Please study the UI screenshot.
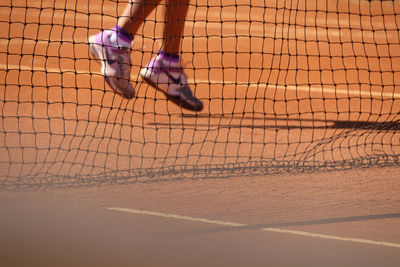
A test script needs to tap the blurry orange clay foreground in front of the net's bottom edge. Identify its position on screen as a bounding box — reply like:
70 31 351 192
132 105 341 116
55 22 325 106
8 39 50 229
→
0 168 400 266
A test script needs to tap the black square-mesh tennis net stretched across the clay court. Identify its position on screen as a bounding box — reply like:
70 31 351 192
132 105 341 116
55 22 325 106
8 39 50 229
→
0 0 400 186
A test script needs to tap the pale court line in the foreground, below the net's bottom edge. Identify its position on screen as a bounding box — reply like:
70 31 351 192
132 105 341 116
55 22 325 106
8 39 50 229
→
103 207 400 248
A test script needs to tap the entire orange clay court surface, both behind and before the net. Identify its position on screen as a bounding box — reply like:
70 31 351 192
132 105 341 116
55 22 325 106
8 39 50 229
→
0 1 400 266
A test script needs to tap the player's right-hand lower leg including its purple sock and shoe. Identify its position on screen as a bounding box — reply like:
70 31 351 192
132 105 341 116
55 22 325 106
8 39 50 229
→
140 0 203 111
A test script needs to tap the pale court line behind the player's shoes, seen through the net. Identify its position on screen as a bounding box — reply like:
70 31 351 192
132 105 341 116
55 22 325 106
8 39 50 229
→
0 64 400 100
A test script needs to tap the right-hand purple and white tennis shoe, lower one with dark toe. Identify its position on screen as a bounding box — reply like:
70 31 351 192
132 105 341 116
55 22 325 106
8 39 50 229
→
140 55 203 111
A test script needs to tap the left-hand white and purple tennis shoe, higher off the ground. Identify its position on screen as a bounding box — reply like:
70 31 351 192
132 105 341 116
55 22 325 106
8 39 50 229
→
89 30 135 98
